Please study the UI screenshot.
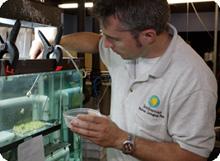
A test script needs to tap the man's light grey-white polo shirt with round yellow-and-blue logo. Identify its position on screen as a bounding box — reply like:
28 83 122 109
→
99 25 217 161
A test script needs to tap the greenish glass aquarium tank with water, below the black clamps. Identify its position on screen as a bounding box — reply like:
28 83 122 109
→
0 70 82 161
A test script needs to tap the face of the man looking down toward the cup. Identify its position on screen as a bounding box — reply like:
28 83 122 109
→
102 16 144 59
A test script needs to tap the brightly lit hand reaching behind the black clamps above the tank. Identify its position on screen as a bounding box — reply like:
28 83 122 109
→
29 40 43 59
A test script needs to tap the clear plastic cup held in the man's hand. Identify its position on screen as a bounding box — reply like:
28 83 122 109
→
63 108 101 128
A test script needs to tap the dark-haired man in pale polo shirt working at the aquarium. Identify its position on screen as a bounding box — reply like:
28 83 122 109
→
31 0 217 161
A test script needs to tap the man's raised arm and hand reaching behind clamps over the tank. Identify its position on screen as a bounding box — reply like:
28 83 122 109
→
29 32 101 59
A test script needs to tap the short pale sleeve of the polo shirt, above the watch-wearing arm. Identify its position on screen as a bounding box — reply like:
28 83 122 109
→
168 89 217 157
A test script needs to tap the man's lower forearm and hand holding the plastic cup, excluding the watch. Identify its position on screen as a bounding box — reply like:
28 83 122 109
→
71 115 207 161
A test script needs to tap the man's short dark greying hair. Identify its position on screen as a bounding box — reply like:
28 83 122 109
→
93 0 170 34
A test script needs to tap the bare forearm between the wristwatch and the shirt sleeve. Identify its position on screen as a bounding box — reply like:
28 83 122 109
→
128 137 207 161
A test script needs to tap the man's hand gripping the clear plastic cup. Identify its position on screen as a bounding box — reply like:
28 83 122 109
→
71 114 127 149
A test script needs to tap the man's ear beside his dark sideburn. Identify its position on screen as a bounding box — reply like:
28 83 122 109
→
140 29 157 44
